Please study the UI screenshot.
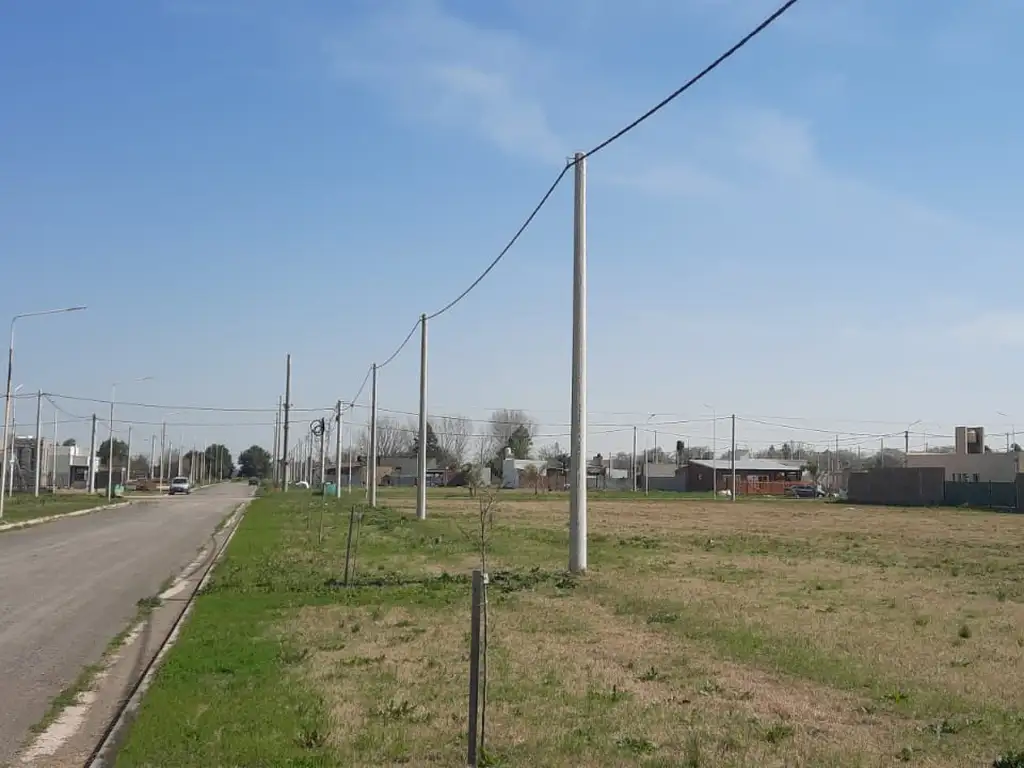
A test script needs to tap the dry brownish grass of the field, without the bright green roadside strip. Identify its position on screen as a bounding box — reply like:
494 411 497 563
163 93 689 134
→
288 495 1024 766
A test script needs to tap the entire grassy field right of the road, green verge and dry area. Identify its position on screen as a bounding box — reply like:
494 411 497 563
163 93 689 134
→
117 490 1024 767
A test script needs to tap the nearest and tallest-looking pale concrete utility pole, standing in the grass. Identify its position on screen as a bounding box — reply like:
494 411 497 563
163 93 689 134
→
569 152 587 573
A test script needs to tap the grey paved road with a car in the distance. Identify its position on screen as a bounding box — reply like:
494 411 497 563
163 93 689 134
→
0 482 251 765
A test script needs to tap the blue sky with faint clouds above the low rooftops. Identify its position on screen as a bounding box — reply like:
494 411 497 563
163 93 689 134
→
6 0 1024 451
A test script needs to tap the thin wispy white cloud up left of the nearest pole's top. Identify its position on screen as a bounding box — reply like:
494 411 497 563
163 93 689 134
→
328 0 564 161
